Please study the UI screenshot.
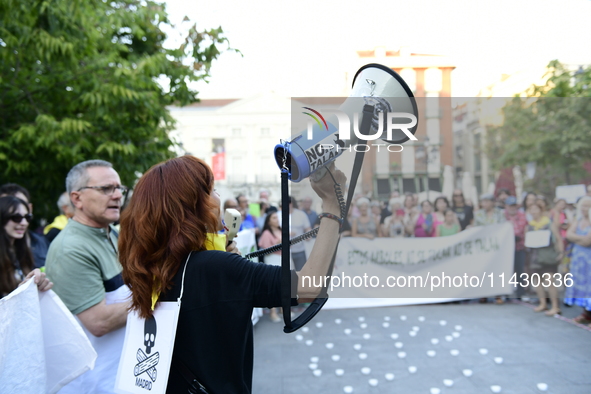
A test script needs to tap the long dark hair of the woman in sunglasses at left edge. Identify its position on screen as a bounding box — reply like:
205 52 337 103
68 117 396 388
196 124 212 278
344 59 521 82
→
0 196 35 294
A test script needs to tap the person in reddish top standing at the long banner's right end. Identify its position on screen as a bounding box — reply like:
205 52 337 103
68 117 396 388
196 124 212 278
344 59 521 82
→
505 196 528 298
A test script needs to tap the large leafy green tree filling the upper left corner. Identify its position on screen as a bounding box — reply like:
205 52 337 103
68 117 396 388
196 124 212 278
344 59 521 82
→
0 0 236 222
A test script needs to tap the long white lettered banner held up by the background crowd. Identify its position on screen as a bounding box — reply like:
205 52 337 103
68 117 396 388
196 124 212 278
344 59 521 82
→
304 223 515 308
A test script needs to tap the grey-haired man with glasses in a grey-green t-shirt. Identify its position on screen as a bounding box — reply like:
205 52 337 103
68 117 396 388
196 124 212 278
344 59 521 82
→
47 160 130 394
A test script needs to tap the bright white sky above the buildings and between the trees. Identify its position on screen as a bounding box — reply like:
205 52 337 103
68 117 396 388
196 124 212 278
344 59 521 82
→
160 0 591 99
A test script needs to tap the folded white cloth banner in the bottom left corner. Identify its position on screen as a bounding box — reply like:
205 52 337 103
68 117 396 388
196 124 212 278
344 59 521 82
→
0 280 97 394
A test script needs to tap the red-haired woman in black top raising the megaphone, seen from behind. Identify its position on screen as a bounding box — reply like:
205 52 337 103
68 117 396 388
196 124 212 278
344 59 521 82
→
119 156 346 394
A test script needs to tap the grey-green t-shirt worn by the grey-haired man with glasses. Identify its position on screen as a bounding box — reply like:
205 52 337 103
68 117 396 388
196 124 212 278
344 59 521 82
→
45 219 123 315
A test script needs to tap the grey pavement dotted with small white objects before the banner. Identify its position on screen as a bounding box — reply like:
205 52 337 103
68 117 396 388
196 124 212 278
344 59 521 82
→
253 301 591 394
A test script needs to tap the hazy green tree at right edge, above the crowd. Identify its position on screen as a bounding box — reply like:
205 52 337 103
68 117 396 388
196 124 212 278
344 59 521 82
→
488 61 591 192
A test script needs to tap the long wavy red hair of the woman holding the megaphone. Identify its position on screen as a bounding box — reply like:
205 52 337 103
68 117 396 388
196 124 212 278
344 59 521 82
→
119 156 219 318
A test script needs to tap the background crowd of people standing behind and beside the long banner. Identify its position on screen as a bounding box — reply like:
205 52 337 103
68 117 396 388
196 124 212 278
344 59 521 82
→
240 185 591 324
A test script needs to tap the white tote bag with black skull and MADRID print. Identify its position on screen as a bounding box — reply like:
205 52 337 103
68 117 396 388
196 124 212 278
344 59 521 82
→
115 254 191 394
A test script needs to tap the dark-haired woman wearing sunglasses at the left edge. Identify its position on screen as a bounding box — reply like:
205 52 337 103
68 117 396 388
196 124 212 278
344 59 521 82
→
0 196 53 297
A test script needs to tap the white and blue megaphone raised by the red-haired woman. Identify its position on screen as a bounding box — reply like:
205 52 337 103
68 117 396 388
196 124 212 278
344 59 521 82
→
275 64 418 182
